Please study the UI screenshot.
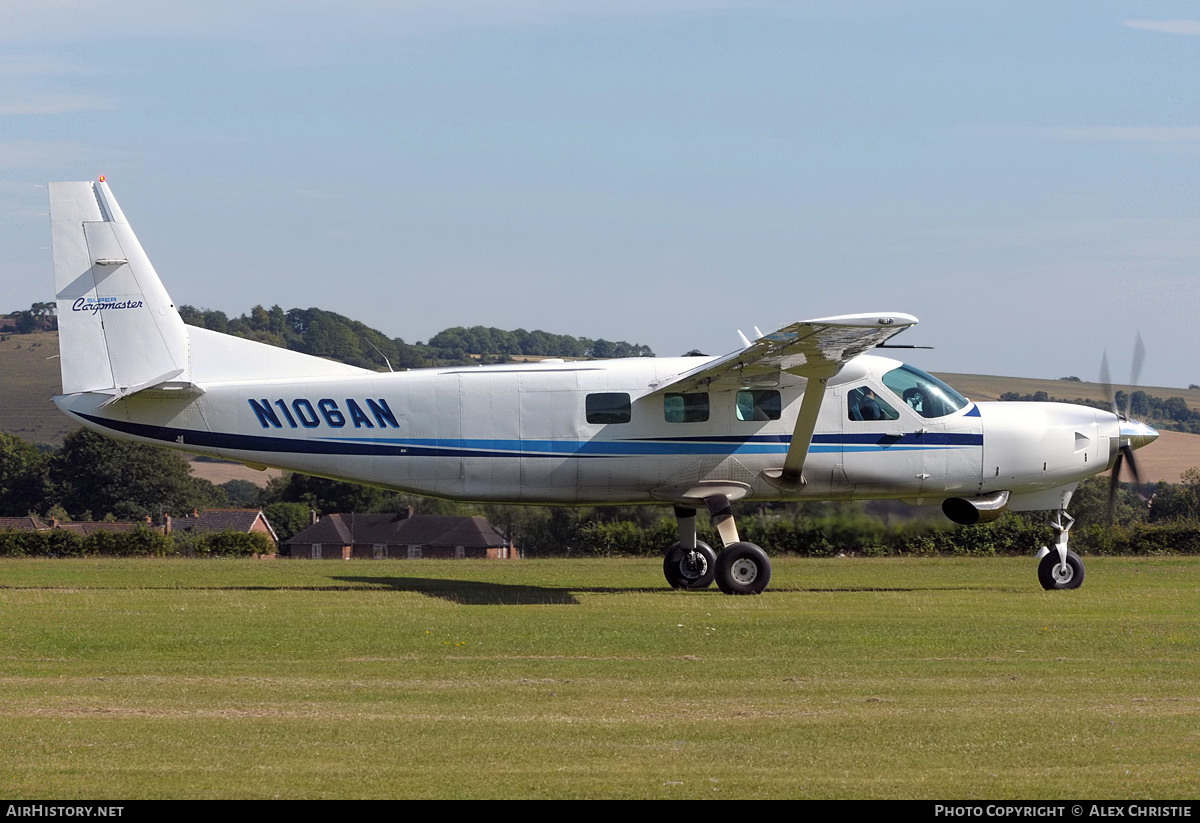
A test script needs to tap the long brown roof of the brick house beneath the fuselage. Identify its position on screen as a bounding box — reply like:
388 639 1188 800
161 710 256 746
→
290 513 508 548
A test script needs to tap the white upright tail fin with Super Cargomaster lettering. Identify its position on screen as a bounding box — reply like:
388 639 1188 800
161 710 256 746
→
50 181 188 400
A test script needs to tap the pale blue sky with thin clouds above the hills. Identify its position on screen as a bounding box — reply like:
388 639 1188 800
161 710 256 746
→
0 0 1200 386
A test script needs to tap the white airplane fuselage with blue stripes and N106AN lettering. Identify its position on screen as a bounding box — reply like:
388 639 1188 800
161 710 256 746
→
58 355 1120 509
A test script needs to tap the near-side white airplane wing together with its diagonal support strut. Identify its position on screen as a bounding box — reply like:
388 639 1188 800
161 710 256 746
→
650 313 917 491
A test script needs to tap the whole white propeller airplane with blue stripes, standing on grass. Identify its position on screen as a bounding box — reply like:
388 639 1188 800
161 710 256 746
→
49 178 1158 594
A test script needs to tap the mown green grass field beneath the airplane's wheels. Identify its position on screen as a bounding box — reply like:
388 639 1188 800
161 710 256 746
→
0 558 1200 799
